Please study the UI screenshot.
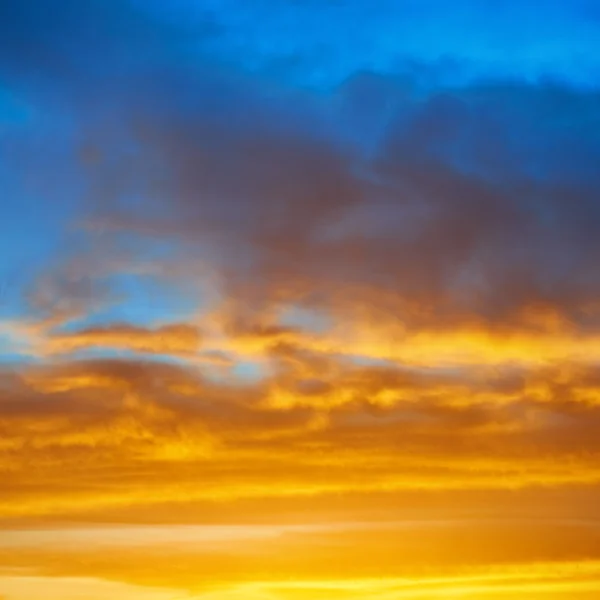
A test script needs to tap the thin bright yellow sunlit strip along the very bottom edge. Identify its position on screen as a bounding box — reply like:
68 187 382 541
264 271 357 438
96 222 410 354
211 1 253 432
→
0 562 600 600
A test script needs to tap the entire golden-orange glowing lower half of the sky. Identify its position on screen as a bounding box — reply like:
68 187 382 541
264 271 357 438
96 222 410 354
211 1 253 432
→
0 282 600 600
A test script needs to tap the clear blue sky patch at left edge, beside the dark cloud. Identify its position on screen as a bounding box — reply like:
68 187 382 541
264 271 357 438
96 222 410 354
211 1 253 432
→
0 79 85 317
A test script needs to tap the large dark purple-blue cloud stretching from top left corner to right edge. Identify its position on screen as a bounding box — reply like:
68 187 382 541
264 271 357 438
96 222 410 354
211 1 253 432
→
2 2 600 332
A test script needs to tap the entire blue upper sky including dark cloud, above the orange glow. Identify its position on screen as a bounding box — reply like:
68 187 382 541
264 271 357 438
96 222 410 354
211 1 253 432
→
0 0 600 360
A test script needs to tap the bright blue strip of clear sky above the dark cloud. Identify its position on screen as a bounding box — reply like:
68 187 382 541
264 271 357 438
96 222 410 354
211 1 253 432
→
137 0 600 89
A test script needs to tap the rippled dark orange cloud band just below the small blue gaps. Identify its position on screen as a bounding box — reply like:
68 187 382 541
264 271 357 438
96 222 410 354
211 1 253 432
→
0 357 600 517
